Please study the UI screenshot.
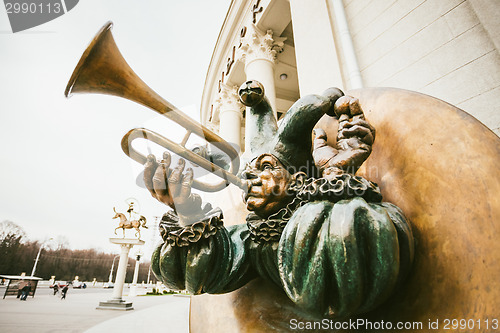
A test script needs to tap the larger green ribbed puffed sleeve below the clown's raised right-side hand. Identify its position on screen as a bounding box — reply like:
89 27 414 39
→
277 198 413 318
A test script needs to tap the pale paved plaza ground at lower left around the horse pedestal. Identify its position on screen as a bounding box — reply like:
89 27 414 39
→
0 287 189 333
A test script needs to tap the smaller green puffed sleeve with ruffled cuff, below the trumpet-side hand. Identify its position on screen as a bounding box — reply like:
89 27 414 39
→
151 210 255 295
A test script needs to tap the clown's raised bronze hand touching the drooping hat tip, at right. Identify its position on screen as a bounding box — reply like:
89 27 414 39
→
313 96 375 178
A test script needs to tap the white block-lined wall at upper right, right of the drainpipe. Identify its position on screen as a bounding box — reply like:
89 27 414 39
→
344 0 500 134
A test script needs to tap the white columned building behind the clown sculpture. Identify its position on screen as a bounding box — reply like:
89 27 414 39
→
201 0 500 223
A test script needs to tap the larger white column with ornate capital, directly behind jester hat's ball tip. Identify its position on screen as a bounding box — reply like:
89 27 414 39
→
237 24 286 117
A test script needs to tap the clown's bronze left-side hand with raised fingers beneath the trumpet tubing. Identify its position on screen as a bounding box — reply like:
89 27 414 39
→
144 152 211 225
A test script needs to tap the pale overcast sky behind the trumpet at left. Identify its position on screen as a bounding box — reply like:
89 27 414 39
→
0 0 230 254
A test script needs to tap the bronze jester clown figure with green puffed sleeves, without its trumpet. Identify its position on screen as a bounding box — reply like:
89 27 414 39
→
144 81 413 318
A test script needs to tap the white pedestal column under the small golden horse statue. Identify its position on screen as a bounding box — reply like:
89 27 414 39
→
97 238 145 311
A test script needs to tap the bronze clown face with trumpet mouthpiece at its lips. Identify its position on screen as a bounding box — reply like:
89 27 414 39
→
242 154 293 217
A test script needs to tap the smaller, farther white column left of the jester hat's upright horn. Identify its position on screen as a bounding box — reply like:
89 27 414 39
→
214 84 245 149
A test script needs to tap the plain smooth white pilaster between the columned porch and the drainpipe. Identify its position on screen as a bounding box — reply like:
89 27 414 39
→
290 0 344 96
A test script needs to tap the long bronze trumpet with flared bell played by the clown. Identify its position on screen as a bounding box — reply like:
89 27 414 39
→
64 22 245 192
